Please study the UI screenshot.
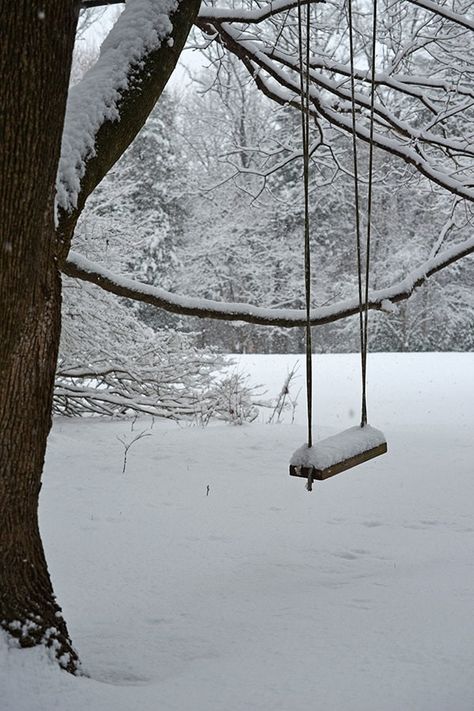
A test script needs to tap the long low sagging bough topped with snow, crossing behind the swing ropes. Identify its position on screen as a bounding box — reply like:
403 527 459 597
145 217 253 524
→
63 238 474 328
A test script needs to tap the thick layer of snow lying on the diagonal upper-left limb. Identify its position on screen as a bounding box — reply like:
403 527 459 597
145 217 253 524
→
57 0 178 211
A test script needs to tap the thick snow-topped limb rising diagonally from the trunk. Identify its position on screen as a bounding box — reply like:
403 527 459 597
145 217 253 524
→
58 0 199 258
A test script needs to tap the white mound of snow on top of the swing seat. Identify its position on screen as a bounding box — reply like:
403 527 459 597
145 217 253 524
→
290 425 386 469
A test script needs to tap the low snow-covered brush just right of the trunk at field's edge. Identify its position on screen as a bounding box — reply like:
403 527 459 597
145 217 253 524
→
53 352 262 424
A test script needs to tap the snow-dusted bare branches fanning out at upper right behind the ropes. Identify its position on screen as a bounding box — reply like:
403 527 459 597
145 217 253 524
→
197 2 474 201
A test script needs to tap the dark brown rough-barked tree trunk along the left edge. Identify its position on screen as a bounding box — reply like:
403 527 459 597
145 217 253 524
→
0 0 78 671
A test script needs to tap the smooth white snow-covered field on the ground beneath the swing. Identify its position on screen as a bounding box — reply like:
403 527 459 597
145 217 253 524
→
0 354 474 711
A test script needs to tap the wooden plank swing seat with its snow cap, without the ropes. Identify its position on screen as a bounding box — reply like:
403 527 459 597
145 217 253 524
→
290 425 387 481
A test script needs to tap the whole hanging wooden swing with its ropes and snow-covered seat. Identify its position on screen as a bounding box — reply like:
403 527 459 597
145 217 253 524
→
290 0 387 491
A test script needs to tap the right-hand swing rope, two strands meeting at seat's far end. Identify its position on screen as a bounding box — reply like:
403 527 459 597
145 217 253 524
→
348 0 377 427
